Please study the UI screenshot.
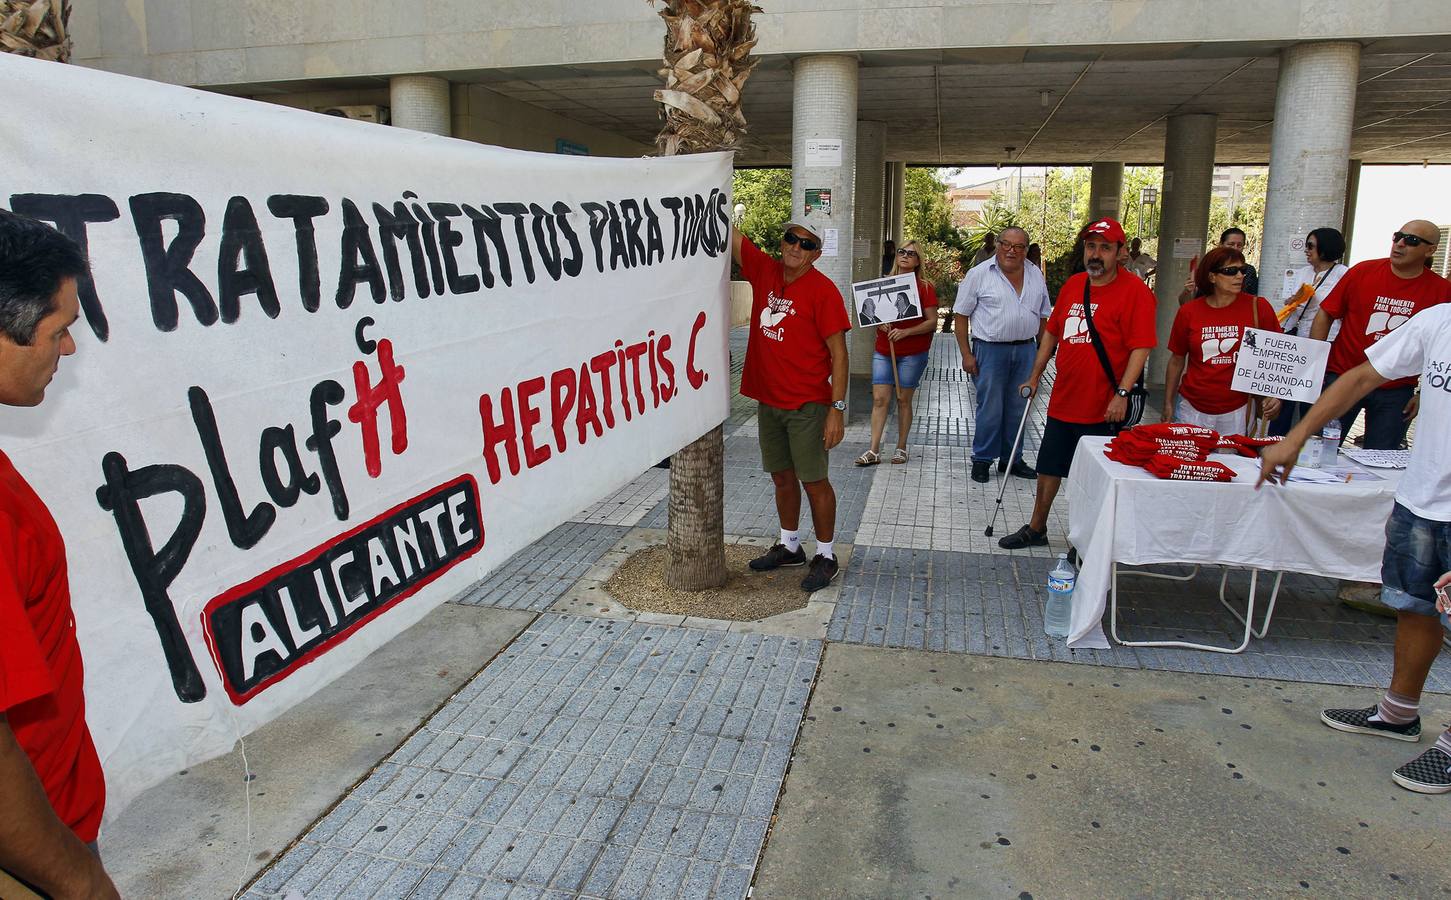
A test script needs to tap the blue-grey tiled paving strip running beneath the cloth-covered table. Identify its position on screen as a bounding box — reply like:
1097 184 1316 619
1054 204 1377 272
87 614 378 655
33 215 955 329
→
827 544 1451 691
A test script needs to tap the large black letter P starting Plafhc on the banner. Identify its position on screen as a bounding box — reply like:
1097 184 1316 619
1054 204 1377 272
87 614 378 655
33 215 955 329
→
96 453 206 703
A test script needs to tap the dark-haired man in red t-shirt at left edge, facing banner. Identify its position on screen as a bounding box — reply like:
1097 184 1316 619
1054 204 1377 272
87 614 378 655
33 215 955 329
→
0 210 116 897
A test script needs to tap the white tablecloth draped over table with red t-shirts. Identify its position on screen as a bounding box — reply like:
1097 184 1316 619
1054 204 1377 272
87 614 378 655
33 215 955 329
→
1068 437 1402 647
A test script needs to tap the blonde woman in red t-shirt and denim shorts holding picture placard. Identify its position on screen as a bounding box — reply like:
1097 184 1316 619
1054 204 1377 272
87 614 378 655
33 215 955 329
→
856 241 937 466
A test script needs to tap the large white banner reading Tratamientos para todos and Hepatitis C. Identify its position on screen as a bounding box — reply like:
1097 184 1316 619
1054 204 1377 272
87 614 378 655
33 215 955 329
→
0 55 731 816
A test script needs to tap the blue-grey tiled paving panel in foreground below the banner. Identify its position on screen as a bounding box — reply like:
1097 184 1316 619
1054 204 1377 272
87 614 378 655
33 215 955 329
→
247 615 821 900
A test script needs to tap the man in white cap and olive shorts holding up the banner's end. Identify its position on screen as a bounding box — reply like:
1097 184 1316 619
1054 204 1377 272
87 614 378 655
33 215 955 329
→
731 221 852 592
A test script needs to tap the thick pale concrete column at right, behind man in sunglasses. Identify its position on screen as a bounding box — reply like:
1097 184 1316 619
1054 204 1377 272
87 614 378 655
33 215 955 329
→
1259 41 1360 306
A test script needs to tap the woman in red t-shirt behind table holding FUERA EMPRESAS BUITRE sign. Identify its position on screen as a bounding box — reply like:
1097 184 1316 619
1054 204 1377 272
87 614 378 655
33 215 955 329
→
1164 247 1280 434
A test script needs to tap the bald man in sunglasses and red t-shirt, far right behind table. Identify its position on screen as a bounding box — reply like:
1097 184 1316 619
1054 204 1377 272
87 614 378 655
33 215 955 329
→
1310 219 1451 450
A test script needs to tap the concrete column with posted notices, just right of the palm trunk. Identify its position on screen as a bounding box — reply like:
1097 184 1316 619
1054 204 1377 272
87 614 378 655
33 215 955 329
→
791 55 858 400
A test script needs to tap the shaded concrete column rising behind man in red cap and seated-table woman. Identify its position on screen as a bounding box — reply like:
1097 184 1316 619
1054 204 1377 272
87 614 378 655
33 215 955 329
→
1146 113 1219 385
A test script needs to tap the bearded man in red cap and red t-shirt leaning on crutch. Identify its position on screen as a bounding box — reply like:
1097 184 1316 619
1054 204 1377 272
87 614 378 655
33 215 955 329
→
998 219 1158 550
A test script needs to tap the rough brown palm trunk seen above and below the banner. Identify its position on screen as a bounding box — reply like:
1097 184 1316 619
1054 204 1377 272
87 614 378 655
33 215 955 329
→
649 0 760 591
